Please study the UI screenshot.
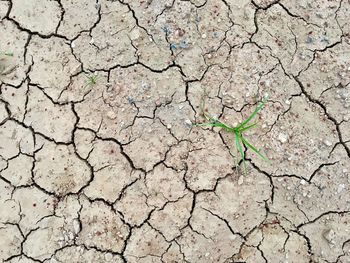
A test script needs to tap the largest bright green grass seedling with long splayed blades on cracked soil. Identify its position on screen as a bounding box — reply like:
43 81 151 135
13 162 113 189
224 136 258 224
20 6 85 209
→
194 96 268 171
